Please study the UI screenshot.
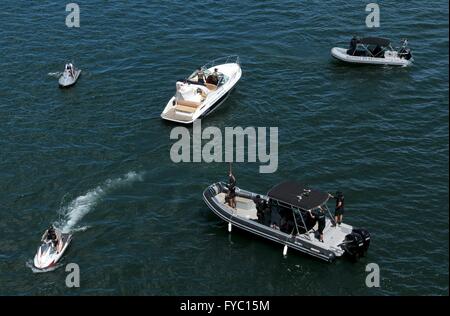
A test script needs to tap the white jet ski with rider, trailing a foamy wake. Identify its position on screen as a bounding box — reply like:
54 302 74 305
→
33 227 72 269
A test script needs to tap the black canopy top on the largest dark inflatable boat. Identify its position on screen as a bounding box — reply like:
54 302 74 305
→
267 181 329 211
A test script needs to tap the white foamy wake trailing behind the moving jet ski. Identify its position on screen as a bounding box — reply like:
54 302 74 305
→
55 171 144 233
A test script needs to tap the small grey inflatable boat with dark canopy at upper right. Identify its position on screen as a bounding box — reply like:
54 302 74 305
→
331 37 413 67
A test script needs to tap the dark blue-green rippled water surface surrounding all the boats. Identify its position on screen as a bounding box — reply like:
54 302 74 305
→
0 0 449 295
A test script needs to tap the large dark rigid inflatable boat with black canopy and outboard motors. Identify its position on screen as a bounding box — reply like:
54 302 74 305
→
203 181 370 262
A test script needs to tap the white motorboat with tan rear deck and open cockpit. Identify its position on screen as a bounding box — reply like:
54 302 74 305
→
161 56 242 124
